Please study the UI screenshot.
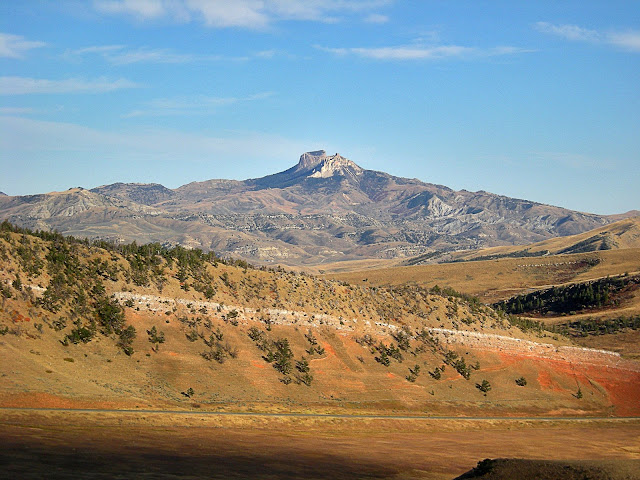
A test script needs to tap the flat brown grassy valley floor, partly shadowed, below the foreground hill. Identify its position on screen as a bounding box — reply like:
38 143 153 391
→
0 408 640 480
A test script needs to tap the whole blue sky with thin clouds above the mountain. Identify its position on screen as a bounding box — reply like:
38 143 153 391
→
0 0 640 214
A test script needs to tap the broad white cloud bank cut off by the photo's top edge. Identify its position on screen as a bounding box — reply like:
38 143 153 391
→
93 0 393 29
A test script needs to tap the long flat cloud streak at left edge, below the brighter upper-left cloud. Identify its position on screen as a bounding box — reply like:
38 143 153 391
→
0 77 140 95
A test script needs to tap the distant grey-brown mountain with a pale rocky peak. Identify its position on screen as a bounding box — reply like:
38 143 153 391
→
0 150 632 265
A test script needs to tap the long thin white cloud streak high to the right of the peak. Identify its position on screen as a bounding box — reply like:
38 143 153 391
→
316 45 532 61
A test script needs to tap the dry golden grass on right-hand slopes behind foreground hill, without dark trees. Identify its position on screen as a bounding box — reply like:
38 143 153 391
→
326 223 640 358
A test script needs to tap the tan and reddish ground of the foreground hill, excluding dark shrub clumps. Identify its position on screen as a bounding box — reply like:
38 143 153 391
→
0 229 640 416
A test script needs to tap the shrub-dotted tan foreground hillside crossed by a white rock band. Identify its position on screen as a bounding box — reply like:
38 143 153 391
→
0 223 640 414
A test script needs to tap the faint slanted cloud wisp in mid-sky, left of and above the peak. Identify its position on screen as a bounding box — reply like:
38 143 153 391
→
123 92 274 118
